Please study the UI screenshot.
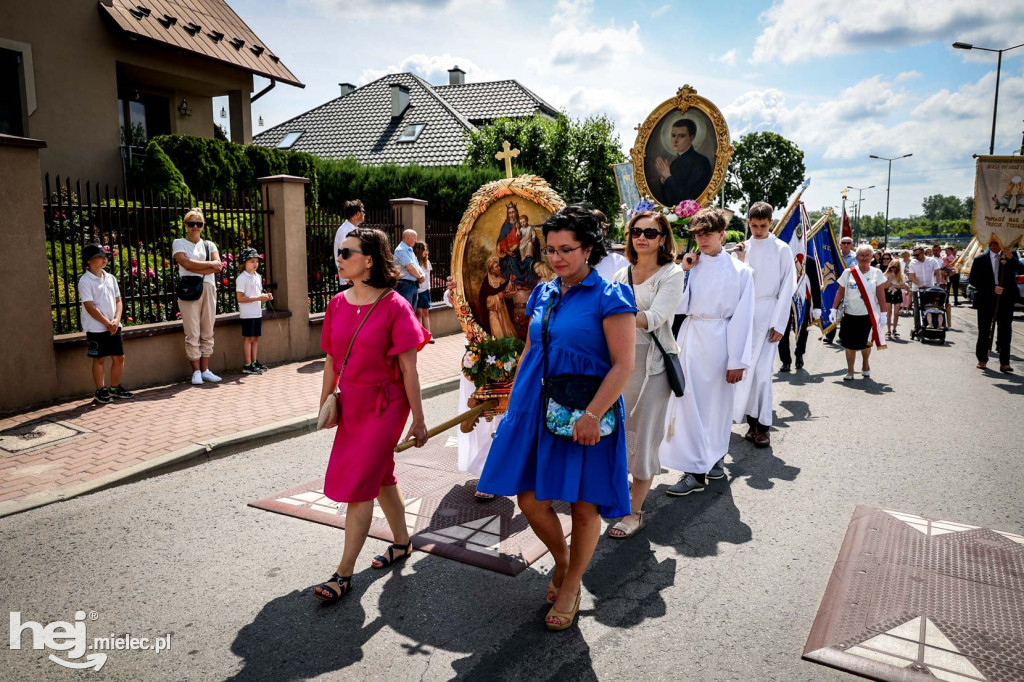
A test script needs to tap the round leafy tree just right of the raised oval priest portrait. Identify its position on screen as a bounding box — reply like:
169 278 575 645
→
725 132 807 213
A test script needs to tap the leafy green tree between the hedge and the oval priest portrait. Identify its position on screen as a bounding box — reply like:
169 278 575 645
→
466 115 626 217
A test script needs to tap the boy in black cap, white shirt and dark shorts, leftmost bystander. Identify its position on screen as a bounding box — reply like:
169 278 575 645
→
78 244 132 404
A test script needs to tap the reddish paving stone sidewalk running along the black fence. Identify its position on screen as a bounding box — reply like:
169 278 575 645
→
0 334 466 516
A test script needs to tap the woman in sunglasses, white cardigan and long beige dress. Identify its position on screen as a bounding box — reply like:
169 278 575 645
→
608 212 683 538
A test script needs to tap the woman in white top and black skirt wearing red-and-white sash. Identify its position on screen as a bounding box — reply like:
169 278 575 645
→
833 244 888 381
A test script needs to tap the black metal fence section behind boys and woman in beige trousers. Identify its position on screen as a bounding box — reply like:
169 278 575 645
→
43 174 273 334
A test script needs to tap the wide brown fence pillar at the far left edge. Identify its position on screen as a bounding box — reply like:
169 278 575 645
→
0 135 59 412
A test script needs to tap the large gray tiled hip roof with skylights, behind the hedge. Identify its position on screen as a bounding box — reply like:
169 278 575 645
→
253 73 473 166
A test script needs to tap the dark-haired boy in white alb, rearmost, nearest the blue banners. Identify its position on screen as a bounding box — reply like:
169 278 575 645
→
735 202 797 447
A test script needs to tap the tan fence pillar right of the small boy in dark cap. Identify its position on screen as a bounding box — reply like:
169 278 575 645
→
259 175 309 361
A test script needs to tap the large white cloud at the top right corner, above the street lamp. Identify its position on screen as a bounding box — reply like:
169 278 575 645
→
751 0 1024 63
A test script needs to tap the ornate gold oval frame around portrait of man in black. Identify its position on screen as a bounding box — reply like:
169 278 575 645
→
630 85 734 207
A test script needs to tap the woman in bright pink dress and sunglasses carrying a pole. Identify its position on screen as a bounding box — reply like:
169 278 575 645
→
313 227 430 601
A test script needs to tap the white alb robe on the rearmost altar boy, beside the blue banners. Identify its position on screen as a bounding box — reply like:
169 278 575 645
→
734 235 797 426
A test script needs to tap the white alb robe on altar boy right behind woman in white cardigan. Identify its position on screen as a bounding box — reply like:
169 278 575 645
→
658 250 754 473
